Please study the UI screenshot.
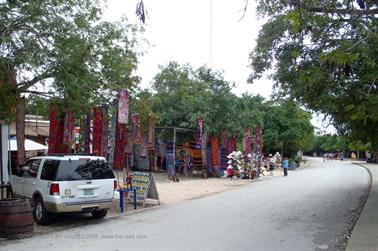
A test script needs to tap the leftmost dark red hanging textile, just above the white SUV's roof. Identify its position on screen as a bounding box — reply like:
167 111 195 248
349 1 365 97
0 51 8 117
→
48 106 64 154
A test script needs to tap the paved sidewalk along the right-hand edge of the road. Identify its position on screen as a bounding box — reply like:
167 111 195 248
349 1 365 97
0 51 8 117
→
345 162 378 251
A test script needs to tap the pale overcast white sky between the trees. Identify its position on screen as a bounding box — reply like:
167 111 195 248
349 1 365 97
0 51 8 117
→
104 0 334 132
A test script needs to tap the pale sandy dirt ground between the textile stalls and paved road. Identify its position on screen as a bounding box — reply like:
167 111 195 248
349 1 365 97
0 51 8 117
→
24 169 282 235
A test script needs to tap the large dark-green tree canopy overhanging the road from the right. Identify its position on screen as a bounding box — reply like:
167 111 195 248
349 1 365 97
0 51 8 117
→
249 0 378 148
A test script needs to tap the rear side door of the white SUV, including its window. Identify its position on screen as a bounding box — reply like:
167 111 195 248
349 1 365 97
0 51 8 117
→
22 159 41 198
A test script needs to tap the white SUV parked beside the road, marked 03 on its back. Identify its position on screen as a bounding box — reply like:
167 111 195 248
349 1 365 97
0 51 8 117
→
12 155 117 225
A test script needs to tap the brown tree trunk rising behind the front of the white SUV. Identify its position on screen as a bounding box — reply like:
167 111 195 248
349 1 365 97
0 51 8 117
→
16 98 26 164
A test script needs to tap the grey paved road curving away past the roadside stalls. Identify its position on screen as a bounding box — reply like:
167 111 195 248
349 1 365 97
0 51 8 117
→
0 160 369 251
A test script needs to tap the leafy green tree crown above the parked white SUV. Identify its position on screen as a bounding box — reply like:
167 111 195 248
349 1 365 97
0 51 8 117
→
0 0 139 159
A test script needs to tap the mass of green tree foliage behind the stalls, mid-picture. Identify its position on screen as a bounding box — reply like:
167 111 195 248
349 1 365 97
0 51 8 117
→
151 62 313 155
